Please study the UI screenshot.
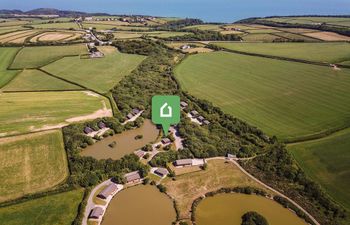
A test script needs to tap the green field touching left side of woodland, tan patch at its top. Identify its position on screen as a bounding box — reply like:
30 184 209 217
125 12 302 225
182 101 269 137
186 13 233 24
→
43 47 145 93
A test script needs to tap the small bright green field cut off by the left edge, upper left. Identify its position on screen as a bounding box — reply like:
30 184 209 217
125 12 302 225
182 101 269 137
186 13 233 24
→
0 48 19 88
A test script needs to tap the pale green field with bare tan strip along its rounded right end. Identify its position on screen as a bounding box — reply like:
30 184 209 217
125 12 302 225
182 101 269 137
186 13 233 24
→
0 91 111 137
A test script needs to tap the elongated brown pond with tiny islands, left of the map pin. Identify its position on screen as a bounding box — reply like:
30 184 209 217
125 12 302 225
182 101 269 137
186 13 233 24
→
81 120 159 159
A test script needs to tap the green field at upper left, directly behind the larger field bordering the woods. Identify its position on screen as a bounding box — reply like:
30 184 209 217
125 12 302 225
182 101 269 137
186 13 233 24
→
11 44 87 69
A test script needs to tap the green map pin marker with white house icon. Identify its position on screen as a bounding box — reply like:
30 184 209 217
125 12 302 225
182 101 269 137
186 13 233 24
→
152 95 180 135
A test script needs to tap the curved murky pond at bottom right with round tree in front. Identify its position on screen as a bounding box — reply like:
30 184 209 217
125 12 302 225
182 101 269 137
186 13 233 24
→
196 194 306 225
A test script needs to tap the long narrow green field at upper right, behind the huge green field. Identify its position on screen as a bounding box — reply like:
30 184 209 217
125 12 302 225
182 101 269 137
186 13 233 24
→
215 42 350 63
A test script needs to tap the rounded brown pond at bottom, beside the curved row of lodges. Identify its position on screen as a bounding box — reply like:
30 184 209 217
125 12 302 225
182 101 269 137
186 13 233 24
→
102 185 176 225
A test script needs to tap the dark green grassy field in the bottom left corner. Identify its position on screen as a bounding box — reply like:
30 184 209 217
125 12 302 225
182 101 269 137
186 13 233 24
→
0 189 84 225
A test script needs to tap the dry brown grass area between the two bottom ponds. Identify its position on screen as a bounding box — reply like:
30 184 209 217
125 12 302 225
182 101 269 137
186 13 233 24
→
162 160 269 219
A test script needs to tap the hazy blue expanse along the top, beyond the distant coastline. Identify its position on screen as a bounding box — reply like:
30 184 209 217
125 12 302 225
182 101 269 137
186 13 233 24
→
0 0 350 22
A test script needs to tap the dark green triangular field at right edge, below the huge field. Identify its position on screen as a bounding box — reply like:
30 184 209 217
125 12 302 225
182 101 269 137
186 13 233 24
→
288 129 350 210
